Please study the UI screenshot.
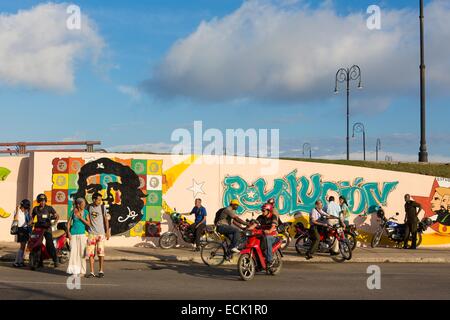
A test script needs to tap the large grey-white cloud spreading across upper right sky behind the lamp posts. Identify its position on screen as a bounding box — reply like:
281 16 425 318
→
144 0 450 105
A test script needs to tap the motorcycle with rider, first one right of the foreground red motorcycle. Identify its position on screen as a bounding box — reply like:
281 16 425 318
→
295 218 352 262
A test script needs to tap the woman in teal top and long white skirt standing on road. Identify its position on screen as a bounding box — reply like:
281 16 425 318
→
67 198 90 275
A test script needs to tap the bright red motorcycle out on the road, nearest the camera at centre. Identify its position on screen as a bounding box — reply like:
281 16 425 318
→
238 221 283 281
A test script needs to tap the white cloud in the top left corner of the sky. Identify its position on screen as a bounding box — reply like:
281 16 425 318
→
0 3 104 92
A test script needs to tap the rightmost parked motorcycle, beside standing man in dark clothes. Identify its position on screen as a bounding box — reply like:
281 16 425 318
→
371 210 433 248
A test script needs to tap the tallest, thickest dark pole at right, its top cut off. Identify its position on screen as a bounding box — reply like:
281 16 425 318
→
419 0 428 162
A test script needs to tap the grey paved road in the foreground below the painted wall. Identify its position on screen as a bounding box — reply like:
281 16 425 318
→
0 261 450 300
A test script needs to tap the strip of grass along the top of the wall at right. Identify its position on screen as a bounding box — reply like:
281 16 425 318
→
282 158 450 178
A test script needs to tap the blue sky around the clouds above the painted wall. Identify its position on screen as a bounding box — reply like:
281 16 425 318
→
0 0 450 161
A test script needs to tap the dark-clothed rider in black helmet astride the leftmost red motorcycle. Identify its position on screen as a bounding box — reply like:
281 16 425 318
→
31 193 59 268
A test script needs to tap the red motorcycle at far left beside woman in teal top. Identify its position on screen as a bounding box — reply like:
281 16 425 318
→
27 215 70 270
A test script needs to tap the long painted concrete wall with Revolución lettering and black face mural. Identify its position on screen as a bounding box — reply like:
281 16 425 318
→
0 152 450 246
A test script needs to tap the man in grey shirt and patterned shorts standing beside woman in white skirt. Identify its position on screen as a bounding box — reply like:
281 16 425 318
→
86 193 111 278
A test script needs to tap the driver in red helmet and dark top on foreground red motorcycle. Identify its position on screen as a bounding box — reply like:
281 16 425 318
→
248 203 278 268
